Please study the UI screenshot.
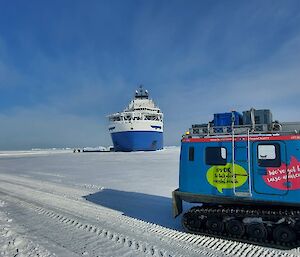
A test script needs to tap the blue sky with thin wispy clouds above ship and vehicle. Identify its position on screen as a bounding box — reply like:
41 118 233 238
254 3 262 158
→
0 0 300 150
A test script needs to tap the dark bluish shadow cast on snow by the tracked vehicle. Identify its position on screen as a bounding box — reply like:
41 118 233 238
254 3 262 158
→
84 189 189 230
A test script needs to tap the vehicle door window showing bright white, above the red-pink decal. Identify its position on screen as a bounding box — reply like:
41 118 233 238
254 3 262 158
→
257 143 281 167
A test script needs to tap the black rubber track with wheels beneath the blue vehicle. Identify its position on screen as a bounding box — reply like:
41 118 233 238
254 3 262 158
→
182 206 300 249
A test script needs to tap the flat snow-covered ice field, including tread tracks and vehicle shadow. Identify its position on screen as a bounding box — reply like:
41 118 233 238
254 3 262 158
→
0 147 300 257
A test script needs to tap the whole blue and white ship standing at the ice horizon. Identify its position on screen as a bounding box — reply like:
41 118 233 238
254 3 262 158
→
108 86 163 152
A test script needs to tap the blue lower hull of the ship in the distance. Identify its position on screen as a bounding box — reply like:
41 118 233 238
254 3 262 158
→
111 131 163 152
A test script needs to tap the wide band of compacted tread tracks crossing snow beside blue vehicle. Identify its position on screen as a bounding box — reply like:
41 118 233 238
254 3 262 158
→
0 175 299 257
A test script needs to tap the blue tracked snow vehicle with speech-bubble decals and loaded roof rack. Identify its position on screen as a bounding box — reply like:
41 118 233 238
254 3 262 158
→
173 109 300 248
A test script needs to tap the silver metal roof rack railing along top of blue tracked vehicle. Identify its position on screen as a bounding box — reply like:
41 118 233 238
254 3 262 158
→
187 122 300 137
